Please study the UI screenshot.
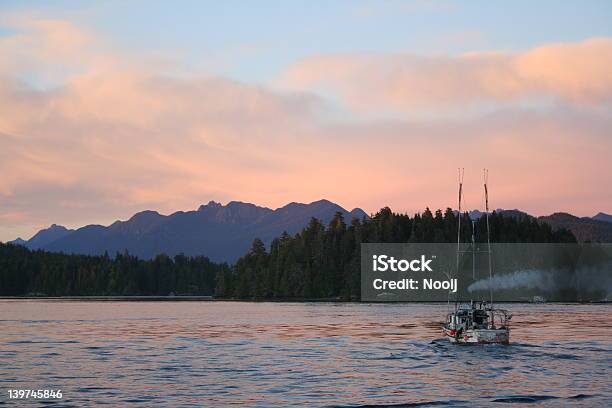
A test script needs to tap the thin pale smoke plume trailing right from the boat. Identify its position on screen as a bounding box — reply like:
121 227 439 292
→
468 269 559 292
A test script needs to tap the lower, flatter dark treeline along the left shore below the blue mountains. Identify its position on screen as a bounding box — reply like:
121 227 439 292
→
0 244 230 296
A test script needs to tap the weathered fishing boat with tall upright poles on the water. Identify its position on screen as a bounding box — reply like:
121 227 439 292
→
443 169 512 344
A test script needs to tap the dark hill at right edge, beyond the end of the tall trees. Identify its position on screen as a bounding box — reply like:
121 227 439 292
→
538 213 612 242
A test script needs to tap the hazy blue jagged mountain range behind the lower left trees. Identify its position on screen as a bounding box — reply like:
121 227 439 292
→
16 200 367 262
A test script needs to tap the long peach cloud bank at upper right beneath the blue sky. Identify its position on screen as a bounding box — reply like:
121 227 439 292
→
278 38 612 111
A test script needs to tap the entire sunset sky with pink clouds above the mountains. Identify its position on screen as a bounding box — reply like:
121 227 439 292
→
0 0 612 241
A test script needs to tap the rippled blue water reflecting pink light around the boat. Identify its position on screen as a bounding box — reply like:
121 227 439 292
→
0 301 612 407
